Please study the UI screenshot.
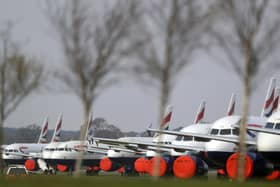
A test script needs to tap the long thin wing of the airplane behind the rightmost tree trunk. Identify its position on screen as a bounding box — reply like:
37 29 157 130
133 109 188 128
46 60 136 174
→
147 128 256 145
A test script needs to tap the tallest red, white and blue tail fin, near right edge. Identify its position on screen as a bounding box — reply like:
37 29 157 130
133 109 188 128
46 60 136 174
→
261 78 276 117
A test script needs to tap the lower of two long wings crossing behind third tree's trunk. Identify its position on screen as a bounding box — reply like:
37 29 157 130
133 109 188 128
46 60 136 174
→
91 138 204 154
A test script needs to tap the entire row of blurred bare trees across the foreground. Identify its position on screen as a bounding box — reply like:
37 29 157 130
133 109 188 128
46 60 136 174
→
0 0 280 181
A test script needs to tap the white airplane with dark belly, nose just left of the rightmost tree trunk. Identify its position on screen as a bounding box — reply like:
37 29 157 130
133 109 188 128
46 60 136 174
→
149 79 276 178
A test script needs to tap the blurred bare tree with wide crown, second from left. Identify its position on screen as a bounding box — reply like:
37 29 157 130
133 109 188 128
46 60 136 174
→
45 0 144 175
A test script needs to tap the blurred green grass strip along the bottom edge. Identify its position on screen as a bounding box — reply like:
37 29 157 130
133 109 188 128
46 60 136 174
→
0 176 280 187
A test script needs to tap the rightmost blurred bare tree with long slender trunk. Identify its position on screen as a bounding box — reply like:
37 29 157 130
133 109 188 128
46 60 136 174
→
208 0 280 181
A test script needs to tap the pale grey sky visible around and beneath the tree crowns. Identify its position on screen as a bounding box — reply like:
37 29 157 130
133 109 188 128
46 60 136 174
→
0 0 280 131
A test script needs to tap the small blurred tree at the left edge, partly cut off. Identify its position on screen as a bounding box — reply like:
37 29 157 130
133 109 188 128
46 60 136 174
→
0 22 43 169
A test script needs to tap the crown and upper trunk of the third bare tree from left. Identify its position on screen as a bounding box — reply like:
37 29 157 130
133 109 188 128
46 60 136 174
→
133 0 207 122
